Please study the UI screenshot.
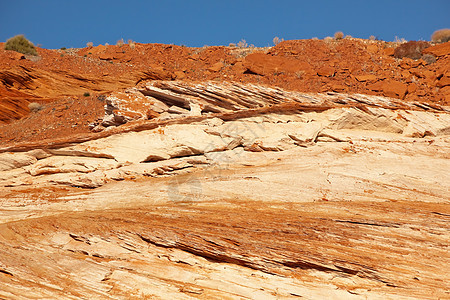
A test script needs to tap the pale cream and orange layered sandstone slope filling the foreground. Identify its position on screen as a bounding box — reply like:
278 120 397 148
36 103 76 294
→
0 81 450 299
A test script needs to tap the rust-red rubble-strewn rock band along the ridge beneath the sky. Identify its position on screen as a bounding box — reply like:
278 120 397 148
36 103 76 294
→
0 38 450 123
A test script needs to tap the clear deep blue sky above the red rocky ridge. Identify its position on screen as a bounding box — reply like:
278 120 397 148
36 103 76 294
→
0 0 450 49
